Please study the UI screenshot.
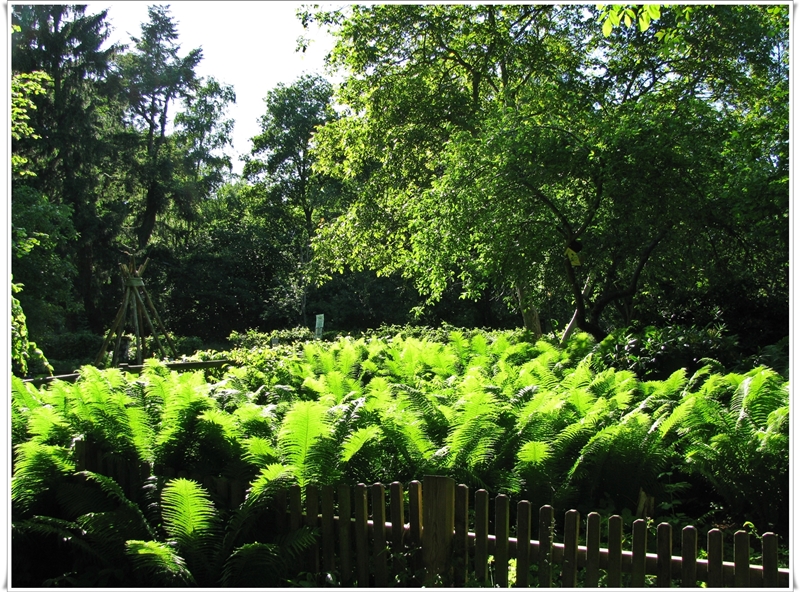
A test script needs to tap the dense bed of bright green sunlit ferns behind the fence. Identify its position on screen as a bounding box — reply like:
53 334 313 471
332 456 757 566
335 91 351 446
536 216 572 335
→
11 330 789 586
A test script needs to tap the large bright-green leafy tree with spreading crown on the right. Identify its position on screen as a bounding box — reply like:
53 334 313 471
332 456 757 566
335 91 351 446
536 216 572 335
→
306 5 786 338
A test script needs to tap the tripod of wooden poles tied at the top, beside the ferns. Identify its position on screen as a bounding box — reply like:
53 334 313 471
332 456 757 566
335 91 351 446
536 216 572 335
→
94 256 177 367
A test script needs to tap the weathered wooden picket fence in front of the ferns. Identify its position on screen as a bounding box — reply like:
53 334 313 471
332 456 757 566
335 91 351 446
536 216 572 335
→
276 476 789 588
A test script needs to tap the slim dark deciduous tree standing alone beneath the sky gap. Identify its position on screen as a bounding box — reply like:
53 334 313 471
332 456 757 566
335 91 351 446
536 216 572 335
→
244 75 340 325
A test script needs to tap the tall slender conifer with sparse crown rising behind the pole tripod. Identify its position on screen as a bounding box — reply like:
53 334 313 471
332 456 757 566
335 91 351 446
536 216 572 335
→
119 5 203 250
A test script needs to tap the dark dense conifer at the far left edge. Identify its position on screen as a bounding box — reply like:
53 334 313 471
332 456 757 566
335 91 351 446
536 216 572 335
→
11 5 124 332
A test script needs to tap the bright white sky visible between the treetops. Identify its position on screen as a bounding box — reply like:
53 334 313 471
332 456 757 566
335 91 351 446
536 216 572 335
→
92 0 340 173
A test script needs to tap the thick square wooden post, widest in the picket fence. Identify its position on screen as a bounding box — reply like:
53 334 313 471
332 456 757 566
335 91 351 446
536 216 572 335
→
422 475 456 586
